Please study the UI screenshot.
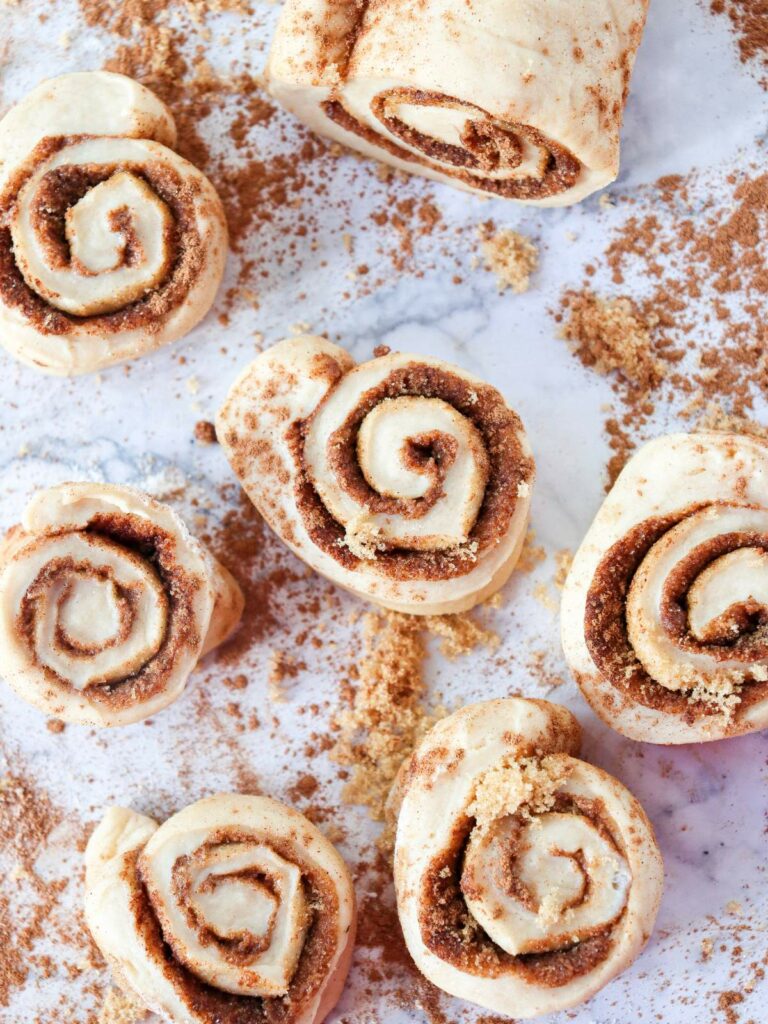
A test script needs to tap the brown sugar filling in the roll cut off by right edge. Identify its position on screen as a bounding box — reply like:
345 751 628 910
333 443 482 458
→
584 506 768 724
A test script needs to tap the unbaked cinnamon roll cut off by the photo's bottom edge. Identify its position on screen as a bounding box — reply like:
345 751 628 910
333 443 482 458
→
85 795 355 1024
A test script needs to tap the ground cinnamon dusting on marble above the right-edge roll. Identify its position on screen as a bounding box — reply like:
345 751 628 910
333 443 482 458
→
555 169 768 483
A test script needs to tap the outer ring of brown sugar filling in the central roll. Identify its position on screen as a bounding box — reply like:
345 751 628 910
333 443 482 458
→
290 362 534 580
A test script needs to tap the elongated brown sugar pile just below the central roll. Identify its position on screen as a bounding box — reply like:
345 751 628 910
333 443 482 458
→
331 612 434 820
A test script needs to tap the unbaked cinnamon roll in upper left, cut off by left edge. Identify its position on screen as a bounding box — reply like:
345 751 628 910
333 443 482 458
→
0 72 227 375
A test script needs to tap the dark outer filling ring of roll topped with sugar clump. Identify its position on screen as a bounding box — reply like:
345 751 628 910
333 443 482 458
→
419 794 624 988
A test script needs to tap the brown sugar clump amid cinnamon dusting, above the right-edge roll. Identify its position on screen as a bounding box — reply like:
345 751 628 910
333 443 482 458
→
561 289 665 391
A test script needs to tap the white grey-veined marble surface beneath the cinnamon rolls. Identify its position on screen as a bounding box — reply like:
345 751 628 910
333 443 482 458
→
0 0 768 1024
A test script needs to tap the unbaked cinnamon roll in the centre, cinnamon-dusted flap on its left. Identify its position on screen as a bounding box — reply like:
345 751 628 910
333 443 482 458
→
217 336 534 614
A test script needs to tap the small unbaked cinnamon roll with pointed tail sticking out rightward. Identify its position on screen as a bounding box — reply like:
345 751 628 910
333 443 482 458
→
0 483 243 726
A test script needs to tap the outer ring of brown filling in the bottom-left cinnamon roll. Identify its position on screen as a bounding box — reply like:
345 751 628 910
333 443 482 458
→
132 828 340 1024
